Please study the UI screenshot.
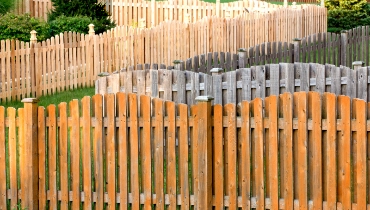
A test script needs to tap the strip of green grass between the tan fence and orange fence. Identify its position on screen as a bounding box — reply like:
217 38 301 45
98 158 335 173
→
0 87 95 109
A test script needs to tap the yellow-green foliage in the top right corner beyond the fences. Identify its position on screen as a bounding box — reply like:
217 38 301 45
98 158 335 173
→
325 0 370 33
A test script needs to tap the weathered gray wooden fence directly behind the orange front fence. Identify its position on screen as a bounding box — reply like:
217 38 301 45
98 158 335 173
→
95 63 370 105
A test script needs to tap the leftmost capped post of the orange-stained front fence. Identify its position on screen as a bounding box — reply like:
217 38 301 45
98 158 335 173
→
20 98 39 210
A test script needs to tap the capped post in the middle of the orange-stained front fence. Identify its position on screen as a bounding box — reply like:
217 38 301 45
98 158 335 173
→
195 96 213 209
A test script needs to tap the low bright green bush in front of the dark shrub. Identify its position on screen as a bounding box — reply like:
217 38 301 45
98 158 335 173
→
49 15 115 36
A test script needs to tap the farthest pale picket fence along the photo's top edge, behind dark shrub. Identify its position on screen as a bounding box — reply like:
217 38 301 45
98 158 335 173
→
13 0 325 28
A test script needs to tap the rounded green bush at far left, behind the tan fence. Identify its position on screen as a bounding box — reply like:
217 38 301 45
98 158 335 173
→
0 13 50 42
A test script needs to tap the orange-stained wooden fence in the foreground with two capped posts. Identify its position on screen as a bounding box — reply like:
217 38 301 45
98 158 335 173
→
0 92 370 210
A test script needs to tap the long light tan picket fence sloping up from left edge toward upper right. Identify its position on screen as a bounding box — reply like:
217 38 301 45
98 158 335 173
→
0 7 322 100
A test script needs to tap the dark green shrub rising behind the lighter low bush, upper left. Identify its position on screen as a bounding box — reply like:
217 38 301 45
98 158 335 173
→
48 0 115 34
